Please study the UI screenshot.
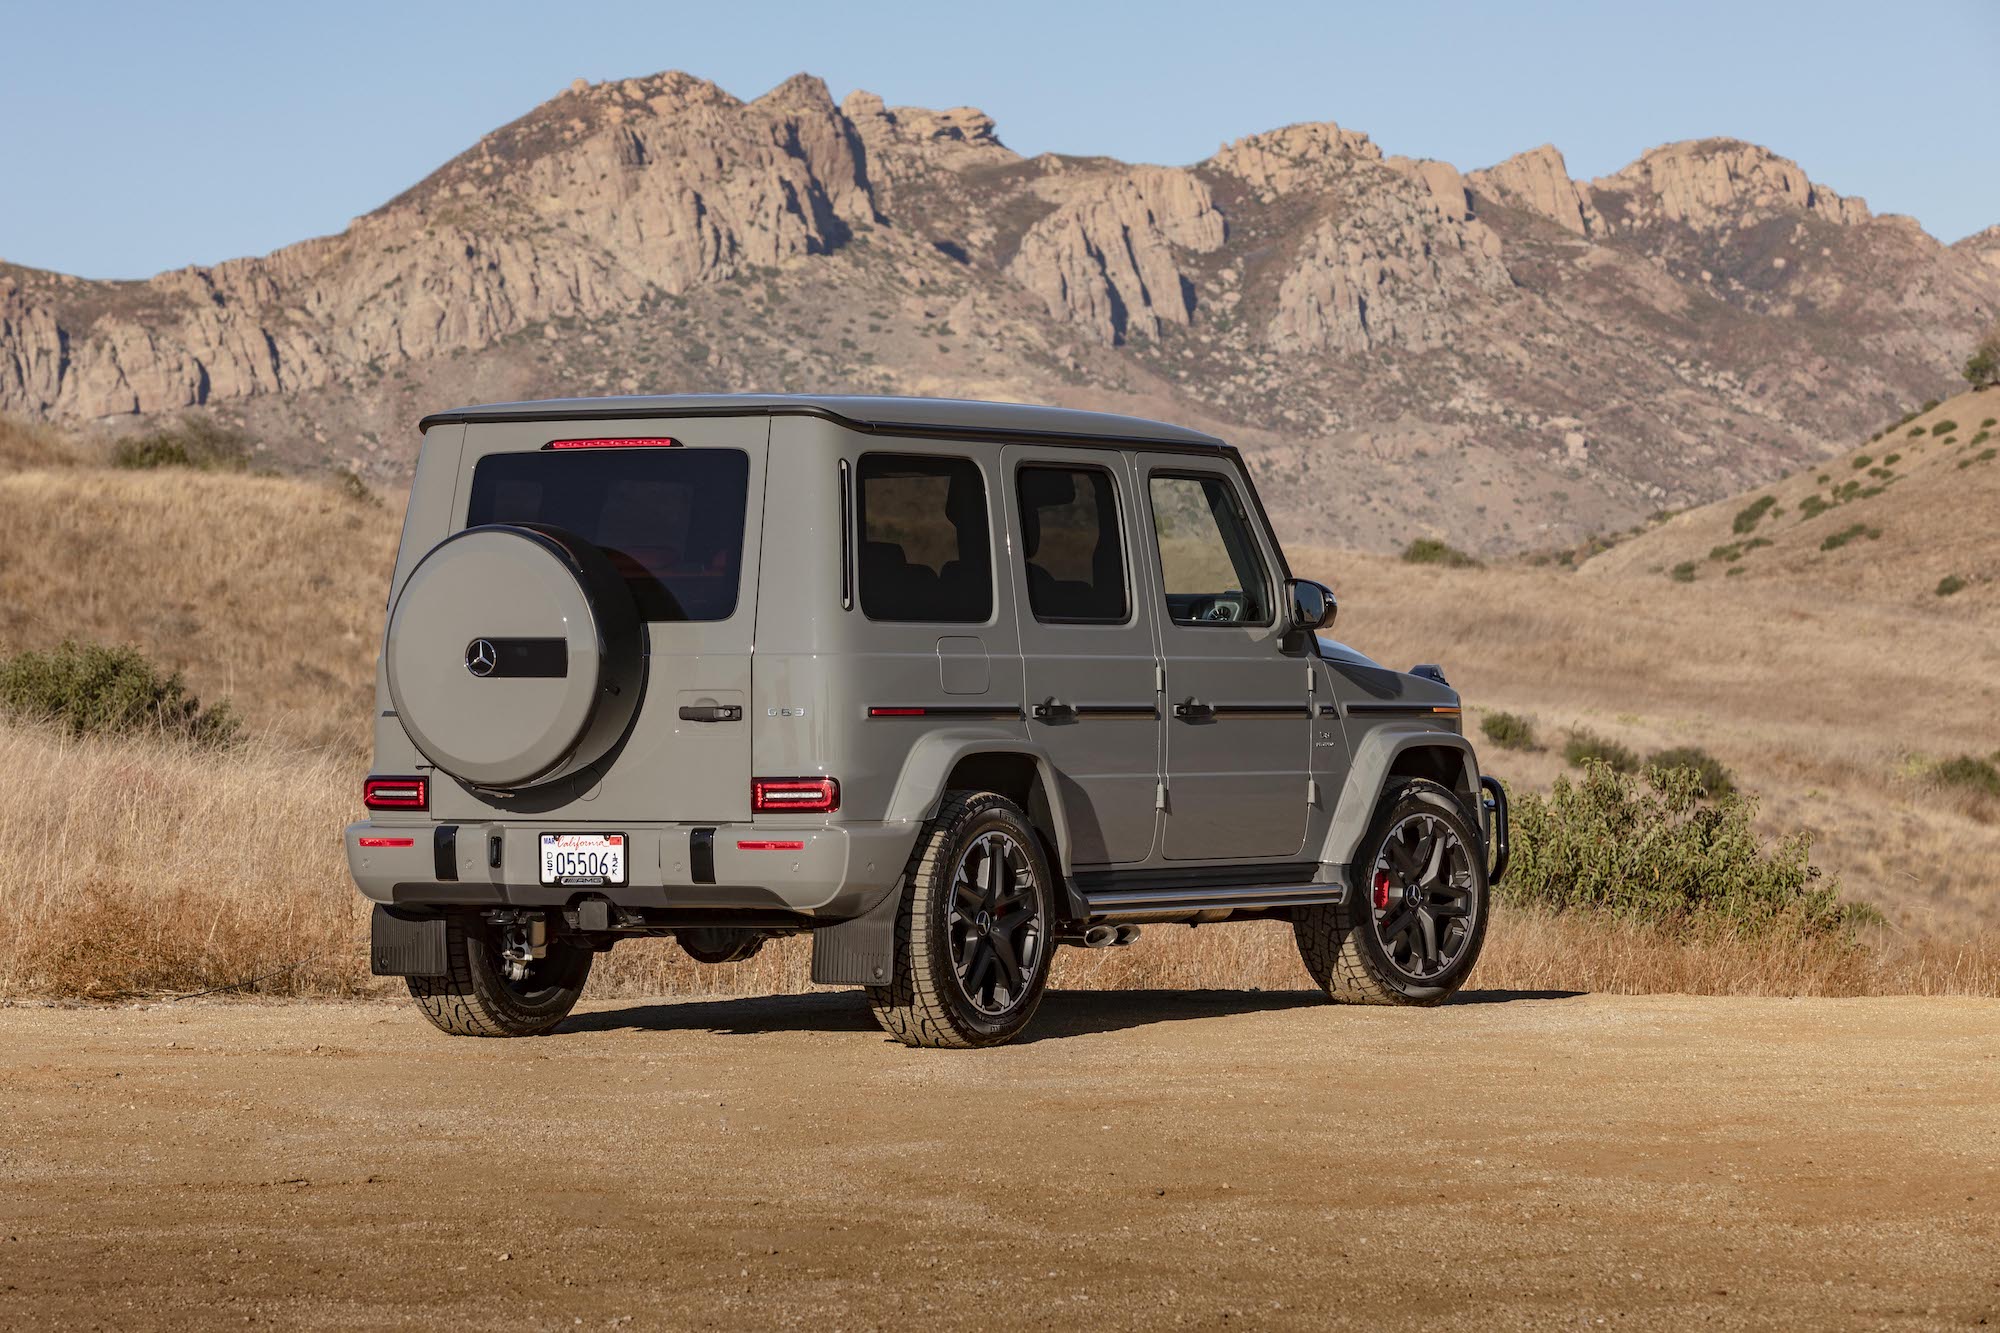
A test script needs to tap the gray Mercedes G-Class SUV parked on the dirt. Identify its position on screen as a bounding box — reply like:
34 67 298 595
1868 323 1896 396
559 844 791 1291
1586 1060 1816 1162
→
346 394 1506 1047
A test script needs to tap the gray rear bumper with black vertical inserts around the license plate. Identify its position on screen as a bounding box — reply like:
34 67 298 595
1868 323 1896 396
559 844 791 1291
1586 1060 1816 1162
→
346 821 920 921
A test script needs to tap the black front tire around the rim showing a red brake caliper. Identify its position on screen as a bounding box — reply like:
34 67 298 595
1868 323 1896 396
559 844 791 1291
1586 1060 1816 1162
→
1292 779 1492 1005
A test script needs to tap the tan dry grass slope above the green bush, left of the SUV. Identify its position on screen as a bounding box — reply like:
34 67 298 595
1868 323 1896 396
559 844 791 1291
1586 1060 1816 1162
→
0 468 400 753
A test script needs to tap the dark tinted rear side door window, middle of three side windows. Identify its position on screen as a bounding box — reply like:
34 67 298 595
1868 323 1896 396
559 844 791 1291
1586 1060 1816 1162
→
1014 464 1130 624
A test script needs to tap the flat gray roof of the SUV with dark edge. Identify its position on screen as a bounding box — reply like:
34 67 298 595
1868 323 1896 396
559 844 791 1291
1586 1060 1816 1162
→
420 394 1228 448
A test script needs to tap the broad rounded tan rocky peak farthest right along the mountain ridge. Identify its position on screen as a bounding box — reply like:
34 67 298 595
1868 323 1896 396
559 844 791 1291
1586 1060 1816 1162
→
1592 138 1870 230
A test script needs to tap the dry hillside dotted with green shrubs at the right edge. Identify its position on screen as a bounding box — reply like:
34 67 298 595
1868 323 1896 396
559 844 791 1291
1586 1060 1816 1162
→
1582 390 2000 600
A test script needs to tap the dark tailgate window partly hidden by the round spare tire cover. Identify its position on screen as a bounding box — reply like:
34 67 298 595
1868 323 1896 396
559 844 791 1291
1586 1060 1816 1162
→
466 448 750 620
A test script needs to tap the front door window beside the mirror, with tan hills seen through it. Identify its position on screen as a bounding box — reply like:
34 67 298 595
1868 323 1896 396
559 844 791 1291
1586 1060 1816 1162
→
1150 474 1272 624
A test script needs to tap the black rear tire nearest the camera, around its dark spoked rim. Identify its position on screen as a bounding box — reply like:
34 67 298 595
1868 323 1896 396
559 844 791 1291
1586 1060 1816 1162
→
868 791 1054 1049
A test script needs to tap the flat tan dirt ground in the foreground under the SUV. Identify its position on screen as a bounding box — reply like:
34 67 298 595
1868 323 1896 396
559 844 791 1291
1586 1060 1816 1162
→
0 993 2000 1331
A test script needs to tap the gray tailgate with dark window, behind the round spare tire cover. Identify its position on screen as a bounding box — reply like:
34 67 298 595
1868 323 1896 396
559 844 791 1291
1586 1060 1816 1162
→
434 416 770 827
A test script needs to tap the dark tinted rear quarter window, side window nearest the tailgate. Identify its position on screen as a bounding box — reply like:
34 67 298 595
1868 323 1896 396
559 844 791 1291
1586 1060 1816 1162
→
854 454 994 624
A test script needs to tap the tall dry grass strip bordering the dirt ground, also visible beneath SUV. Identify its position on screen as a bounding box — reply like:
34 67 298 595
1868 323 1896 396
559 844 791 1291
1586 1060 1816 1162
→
0 725 2000 999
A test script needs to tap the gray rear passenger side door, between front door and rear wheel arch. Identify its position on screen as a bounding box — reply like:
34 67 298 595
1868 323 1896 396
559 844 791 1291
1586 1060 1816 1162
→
1002 446 1160 865
